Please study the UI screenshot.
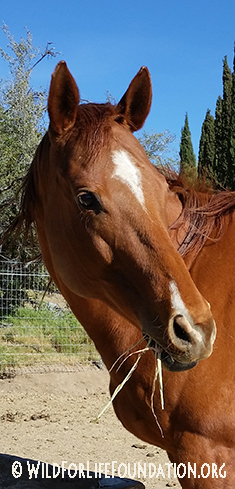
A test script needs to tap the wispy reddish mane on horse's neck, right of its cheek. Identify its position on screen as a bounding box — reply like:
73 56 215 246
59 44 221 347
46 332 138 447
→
160 168 235 261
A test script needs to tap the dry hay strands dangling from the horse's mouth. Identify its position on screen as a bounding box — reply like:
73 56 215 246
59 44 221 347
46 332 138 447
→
95 338 164 438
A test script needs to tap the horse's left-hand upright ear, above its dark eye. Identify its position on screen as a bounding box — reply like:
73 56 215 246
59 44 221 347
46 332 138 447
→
48 61 79 134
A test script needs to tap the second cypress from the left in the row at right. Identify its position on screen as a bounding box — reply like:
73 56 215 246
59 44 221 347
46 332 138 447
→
198 109 215 179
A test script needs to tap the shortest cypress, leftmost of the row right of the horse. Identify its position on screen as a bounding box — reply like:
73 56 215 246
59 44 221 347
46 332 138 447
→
180 113 197 181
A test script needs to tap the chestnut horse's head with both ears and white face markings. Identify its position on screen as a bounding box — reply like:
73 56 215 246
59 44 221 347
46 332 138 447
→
28 62 215 370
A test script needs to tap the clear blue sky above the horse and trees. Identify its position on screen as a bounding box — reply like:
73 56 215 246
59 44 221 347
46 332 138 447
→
0 0 235 159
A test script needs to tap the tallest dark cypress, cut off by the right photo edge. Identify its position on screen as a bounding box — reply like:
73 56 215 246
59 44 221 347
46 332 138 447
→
228 43 235 190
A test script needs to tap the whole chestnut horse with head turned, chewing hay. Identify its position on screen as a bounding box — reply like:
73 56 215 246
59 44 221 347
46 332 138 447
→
8 62 235 489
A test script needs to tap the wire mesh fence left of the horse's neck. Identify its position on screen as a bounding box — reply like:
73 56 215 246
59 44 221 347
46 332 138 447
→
0 261 100 376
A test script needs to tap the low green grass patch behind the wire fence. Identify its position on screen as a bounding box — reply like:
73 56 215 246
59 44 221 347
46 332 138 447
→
0 304 98 374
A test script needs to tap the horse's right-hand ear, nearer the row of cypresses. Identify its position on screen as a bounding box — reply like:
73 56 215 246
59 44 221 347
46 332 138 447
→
117 66 152 132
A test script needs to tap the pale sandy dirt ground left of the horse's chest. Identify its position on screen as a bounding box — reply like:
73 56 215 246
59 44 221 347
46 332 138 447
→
0 366 180 489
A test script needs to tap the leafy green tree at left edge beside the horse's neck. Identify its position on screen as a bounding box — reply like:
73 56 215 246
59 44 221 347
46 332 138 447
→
0 24 56 255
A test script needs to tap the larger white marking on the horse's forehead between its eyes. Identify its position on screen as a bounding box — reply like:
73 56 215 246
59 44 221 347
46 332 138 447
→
112 149 145 207
